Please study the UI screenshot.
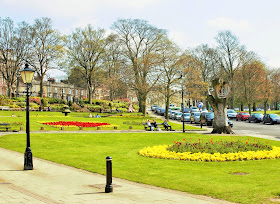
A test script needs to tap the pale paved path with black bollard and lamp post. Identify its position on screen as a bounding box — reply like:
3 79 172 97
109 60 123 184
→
0 148 228 204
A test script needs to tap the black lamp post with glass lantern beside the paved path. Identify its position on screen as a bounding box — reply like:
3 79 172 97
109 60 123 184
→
20 63 35 170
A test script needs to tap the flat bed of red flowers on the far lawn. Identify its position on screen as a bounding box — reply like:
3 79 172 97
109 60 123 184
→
42 121 110 127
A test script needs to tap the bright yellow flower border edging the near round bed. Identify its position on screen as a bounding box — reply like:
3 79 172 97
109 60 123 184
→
138 145 280 162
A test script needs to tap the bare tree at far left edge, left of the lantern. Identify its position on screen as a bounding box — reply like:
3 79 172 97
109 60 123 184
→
0 18 30 98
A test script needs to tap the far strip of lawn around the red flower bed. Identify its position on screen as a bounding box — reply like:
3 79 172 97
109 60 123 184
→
0 111 200 131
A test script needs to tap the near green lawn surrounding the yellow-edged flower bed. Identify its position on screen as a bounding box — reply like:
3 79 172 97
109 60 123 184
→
0 133 280 204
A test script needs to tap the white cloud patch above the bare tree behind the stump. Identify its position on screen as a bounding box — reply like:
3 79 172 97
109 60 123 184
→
207 17 250 31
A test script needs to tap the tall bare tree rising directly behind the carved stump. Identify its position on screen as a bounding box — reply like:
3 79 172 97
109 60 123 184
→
216 30 244 108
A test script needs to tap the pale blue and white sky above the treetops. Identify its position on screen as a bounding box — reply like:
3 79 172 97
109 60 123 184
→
0 0 280 77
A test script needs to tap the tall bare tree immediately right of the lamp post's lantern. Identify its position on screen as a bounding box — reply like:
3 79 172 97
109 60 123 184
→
28 18 64 97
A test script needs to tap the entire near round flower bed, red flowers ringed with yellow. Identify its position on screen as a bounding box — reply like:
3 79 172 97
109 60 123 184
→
138 139 280 162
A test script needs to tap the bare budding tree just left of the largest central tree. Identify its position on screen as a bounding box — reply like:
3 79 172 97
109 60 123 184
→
66 25 109 104
